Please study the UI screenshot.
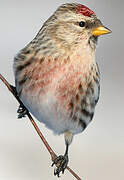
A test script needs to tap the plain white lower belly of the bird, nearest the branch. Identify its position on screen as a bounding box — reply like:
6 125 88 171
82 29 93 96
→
20 92 83 134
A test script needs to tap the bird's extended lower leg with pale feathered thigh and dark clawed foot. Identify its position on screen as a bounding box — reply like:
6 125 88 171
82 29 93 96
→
52 132 73 177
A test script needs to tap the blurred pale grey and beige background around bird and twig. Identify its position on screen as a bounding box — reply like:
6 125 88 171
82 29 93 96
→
0 0 124 180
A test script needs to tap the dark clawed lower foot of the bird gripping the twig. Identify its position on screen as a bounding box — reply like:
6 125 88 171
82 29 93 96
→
52 155 68 177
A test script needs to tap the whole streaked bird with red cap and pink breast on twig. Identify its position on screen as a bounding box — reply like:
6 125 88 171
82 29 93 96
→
13 3 111 177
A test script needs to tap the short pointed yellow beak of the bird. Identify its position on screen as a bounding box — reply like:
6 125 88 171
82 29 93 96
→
91 26 111 36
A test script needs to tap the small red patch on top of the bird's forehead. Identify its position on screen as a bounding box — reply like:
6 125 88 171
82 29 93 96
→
76 4 95 17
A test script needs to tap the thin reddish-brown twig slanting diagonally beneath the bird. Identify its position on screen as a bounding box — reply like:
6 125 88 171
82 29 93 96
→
0 74 81 180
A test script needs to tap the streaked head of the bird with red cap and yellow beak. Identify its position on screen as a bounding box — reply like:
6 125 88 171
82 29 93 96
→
34 3 111 57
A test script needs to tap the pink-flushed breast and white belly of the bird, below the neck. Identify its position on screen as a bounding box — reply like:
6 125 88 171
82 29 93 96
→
17 59 99 133
